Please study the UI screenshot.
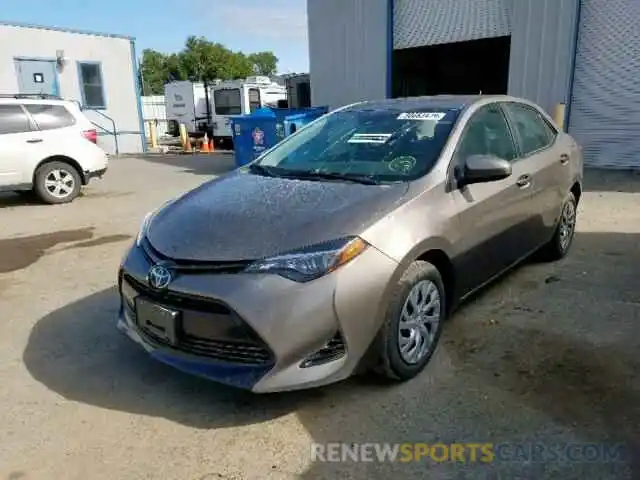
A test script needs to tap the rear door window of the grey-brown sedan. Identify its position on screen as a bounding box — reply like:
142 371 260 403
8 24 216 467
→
504 103 557 156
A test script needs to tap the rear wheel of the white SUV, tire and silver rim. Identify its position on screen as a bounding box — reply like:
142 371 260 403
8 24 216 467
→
34 162 82 204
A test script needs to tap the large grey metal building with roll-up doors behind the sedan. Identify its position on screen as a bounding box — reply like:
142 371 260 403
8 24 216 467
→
307 0 640 168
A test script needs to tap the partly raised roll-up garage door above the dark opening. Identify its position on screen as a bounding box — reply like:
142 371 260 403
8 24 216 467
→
393 0 519 49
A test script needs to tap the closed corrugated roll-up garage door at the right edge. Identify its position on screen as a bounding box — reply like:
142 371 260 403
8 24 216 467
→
569 0 640 168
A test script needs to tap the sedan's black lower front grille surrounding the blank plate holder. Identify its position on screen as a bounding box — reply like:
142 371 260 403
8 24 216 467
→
124 276 273 365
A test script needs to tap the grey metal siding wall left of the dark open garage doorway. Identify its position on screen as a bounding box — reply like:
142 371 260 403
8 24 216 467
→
307 0 388 109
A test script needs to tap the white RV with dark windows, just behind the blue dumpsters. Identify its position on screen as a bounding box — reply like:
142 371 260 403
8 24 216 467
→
211 76 287 145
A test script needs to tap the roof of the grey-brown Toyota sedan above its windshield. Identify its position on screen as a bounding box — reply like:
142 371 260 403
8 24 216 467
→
344 95 520 112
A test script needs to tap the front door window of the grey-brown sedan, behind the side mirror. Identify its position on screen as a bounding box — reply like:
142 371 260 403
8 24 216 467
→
457 105 518 163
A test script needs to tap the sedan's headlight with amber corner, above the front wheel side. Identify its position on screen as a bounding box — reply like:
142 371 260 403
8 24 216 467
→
245 237 369 282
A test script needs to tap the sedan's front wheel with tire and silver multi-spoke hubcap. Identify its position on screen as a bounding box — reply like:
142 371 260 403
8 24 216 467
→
376 261 446 381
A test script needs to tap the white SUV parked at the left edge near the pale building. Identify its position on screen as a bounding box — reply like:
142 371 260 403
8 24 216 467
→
0 95 107 203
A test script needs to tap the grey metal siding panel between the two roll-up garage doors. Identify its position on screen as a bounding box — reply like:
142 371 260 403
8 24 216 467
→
509 0 578 113
